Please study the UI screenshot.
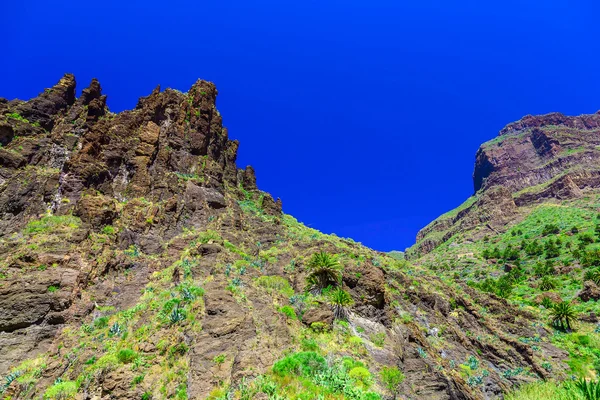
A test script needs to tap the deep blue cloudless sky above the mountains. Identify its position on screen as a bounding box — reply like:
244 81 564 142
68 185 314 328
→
0 0 600 250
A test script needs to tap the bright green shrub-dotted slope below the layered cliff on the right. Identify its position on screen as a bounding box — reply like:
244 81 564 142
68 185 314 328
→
419 195 600 386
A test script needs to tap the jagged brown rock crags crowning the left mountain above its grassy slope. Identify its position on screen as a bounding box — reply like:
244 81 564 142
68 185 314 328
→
0 74 281 241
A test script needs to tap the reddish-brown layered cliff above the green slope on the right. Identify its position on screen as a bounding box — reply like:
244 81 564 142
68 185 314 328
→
412 108 600 255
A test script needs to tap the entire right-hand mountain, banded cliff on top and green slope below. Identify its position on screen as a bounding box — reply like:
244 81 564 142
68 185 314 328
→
407 107 600 398
